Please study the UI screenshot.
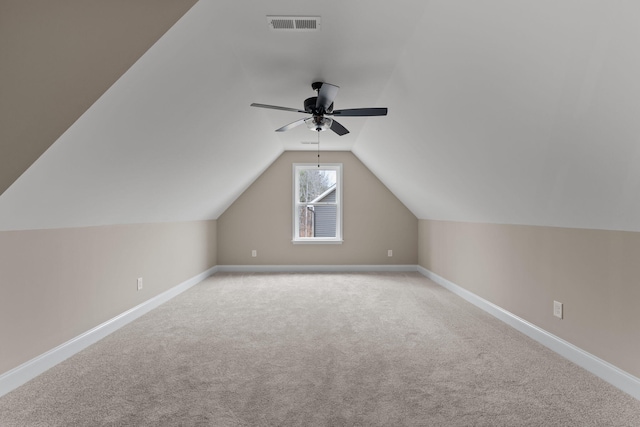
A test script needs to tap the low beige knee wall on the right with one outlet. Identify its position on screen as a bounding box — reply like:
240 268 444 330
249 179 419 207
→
419 220 640 377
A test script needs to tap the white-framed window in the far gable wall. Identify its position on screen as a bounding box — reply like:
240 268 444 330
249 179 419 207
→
293 163 342 243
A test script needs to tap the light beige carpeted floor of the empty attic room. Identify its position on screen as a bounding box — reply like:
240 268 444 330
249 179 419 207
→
0 273 640 427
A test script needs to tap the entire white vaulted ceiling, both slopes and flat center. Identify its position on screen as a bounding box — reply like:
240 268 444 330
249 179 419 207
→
0 0 640 231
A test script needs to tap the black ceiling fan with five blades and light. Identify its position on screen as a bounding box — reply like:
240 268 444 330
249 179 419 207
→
251 82 387 136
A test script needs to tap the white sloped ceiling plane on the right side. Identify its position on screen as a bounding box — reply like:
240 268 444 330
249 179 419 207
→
353 0 640 231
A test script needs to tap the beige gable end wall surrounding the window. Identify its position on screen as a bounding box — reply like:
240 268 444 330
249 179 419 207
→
218 151 418 265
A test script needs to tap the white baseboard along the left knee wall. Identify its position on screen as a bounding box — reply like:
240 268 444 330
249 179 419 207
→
0 266 218 396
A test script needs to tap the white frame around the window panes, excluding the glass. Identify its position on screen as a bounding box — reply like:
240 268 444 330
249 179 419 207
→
292 163 343 244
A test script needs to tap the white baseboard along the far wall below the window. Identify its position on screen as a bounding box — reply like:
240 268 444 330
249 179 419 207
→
218 264 417 273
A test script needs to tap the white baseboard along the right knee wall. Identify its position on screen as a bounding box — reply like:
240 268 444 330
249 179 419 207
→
418 266 640 400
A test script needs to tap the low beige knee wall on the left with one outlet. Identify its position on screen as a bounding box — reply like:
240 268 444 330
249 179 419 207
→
0 221 217 374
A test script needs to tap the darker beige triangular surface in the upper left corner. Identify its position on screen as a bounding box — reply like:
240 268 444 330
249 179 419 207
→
0 0 196 194
